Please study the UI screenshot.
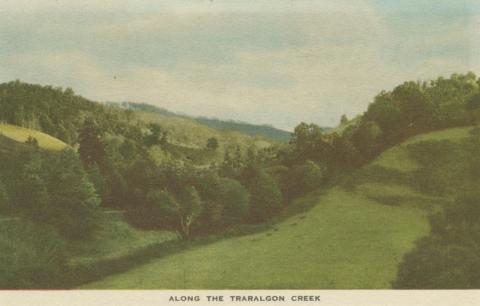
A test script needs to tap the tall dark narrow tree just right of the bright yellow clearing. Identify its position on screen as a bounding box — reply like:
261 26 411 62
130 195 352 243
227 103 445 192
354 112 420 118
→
78 118 106 168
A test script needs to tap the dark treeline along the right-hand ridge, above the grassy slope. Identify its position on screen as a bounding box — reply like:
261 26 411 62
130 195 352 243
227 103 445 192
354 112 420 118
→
278 72 480 186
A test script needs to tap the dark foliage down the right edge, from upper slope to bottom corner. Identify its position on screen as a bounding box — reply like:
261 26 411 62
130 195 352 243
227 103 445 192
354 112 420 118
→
394 129 480 289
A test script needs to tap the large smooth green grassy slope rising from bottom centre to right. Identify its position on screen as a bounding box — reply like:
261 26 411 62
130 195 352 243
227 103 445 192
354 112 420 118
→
80 128 469 289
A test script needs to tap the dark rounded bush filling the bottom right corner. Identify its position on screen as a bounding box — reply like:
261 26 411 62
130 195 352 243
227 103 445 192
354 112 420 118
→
393 193 480 289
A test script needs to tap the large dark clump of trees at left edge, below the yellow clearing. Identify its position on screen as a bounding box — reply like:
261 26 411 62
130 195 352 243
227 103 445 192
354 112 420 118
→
0 149 99 239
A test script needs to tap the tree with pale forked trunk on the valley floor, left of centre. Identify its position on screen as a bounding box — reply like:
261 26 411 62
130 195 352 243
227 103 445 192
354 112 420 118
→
147 186 203 239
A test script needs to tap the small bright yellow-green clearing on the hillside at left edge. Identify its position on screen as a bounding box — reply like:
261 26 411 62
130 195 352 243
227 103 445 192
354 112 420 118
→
0 124 67 151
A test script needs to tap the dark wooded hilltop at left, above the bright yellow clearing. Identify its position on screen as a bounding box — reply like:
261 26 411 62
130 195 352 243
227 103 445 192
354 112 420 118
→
0 80 138 145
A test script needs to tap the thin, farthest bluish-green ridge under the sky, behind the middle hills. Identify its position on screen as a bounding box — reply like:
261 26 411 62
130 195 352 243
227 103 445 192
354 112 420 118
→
107 102 291 142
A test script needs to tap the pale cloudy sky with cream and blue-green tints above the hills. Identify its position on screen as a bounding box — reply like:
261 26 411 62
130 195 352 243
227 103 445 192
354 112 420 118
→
0 0 480 130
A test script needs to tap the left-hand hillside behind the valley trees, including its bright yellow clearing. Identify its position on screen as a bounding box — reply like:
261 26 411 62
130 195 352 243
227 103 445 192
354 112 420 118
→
0 81 275 166
